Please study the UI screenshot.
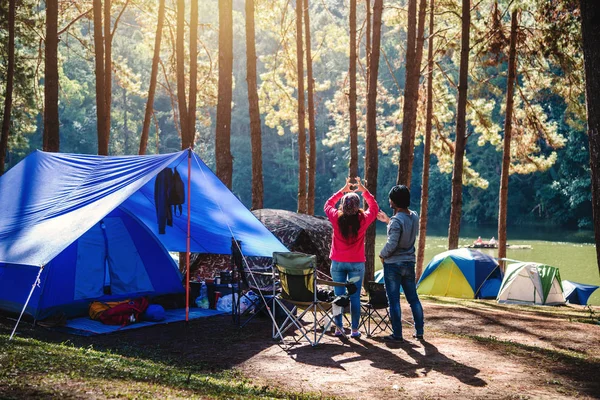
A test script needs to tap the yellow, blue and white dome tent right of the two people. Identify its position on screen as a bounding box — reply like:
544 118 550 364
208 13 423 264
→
417 248 502 299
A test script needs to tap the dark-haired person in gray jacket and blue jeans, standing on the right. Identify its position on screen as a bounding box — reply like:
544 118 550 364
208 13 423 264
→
377 185 424 342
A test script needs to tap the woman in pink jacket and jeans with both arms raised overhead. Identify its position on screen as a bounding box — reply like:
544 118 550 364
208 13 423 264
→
325 177 379 337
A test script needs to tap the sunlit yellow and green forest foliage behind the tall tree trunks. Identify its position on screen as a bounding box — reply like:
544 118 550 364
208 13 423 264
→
0 0 592 229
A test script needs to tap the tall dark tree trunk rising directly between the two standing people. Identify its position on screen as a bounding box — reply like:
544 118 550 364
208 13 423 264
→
365 0 383 281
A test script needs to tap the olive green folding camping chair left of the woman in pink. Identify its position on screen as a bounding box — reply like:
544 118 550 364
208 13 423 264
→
273 252 346 346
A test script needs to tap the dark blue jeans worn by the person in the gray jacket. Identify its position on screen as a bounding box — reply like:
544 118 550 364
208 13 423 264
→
383 261 424 338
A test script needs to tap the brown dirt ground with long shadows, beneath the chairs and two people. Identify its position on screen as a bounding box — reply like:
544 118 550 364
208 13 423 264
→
2 298 600 399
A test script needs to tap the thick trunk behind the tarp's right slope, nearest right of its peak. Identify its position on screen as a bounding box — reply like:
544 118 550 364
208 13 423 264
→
215 0 233 189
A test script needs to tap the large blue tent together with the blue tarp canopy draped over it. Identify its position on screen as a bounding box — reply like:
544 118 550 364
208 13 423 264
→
0 150 287 318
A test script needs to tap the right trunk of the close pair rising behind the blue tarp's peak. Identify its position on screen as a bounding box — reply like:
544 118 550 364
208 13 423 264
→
186 0 198 150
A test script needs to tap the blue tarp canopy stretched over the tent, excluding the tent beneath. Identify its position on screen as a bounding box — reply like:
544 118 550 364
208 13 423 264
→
0 150 286 266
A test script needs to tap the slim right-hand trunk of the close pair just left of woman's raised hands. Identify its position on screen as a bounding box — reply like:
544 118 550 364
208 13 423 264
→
304 0 317 215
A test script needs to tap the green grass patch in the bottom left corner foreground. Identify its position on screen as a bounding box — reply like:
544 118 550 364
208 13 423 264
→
0 335 332 399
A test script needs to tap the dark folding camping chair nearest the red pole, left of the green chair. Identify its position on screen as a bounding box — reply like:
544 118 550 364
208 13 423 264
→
231 239 277 328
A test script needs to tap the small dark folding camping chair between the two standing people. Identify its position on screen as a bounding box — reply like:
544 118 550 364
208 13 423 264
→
360 281 390 337
